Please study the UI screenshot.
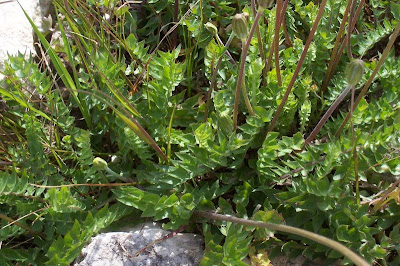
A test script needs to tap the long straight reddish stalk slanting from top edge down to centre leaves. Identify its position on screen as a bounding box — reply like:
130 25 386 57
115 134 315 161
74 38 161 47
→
267 0 327 133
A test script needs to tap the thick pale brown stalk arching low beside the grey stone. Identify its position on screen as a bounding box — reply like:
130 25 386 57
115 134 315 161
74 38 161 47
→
194 211 369 266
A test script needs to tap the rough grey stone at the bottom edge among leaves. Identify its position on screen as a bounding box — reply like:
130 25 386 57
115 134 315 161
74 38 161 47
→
74 223 204 266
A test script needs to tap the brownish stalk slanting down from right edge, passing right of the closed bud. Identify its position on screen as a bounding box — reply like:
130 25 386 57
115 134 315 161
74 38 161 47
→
335 22 400 137
